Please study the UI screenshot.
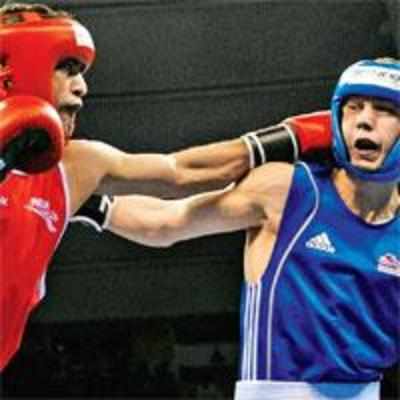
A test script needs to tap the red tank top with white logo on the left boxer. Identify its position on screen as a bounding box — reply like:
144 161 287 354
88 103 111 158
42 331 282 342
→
0 166 69 371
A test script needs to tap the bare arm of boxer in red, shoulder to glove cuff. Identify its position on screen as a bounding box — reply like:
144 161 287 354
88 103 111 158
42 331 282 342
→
63 139 249 213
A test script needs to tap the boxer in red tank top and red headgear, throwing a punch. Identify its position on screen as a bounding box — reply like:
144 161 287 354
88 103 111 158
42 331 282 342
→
0 3 330 370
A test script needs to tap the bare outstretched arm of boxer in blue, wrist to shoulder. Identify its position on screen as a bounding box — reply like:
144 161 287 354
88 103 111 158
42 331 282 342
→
73 163 293 247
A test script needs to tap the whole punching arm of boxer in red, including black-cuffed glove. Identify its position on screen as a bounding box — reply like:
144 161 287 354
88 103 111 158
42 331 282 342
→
63 112 331 213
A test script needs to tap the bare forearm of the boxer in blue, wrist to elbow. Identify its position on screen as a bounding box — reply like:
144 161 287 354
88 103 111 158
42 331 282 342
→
107 187 238 247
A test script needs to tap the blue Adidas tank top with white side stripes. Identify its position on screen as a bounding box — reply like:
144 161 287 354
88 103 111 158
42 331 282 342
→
240 163 400 382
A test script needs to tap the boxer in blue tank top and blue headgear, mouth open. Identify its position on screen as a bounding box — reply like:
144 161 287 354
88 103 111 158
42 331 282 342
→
97 58 400 400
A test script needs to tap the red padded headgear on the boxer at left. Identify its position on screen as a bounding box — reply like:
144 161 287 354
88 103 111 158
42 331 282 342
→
0 11 95 106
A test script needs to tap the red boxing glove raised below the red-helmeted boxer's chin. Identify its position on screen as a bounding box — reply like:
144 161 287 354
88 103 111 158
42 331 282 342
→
0 96 64 181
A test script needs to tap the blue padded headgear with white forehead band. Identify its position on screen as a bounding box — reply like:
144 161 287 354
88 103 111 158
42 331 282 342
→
331 59 400 182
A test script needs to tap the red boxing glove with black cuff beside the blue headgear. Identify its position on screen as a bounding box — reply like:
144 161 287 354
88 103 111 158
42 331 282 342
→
242 111 332 168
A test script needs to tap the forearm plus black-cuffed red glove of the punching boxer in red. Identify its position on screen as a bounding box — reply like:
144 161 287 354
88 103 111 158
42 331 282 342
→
173 111 332 189
